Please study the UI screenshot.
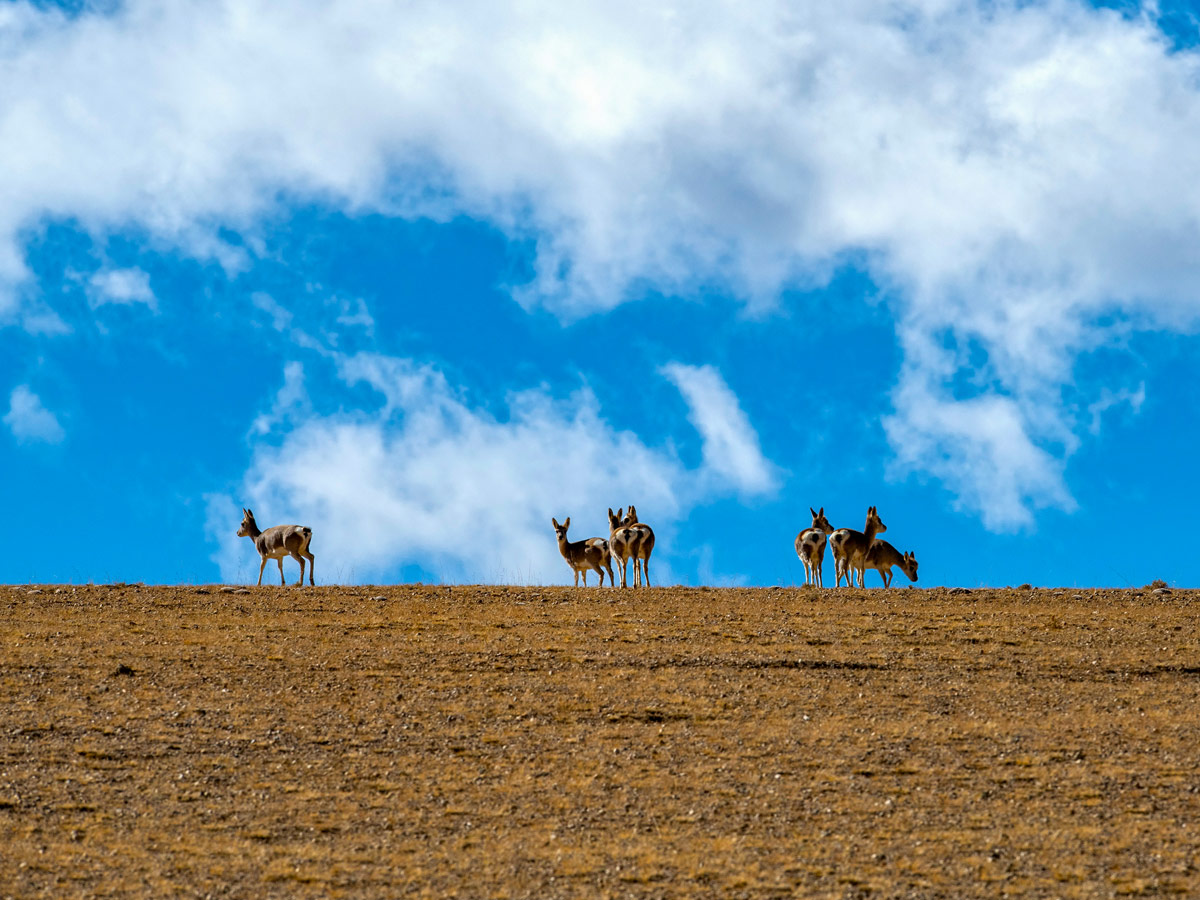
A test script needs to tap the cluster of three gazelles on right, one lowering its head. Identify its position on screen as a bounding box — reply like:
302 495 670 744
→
796 506 917 588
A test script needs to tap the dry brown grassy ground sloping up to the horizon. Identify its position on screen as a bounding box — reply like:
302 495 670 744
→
0 584 1200 900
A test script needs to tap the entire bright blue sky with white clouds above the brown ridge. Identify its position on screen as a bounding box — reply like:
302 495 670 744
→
0 0 1200 587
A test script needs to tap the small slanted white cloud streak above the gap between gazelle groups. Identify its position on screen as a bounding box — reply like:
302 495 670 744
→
660 362 778 494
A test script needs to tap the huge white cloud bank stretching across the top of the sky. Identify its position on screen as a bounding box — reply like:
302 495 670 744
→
0 0 1200 527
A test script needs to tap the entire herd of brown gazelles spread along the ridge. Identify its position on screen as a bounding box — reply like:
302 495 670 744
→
231 504 917 588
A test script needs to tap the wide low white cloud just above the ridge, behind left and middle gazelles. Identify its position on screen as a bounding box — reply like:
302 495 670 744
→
209 353 770 583
